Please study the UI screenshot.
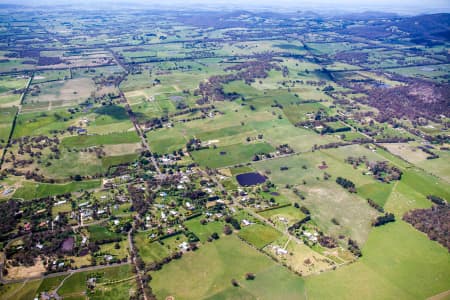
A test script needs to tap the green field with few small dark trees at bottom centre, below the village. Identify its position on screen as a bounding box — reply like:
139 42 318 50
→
151 236 304 299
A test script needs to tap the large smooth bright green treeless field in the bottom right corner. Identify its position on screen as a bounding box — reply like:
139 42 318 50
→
305 221 450 299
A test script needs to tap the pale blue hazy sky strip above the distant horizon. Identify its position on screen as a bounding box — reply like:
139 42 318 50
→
5 0 450 14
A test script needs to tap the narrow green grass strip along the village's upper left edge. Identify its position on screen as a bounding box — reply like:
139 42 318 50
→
13 180 100 200
